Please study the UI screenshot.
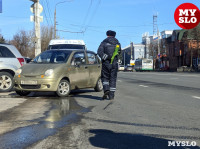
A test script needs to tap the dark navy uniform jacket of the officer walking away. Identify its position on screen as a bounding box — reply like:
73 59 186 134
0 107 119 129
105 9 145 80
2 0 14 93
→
97 37 121 62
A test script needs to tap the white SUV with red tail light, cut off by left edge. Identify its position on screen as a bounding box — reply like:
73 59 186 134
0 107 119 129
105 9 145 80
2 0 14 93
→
0 44 26 92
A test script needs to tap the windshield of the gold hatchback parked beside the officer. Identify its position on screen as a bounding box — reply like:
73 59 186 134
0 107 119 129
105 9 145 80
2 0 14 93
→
33 50 71 63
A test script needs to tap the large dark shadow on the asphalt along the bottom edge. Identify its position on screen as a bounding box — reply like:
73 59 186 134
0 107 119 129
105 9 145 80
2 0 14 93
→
89 129 199 149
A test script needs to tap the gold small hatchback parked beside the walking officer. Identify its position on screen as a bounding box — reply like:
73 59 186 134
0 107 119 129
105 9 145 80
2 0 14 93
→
15 50 103 97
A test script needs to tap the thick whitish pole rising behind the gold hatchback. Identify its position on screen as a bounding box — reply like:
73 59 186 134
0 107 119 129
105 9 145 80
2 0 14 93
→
31 0 43 56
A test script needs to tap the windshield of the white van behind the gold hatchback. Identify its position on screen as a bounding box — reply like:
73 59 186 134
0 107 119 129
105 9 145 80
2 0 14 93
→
48 44 85 50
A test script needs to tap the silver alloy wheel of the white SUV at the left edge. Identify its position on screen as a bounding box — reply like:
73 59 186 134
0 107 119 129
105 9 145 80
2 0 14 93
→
0 72 14 92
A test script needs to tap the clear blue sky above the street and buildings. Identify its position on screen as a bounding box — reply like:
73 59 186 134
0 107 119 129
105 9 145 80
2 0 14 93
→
0 0 200 52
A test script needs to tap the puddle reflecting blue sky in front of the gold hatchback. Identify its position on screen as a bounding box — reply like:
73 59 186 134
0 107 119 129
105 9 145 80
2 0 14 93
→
0 97 90 148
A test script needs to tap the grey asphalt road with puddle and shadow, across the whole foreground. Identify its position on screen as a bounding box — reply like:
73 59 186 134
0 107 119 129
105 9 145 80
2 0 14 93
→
0 72 200 149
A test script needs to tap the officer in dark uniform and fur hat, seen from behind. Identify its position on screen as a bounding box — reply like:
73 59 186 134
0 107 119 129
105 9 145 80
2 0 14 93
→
97 30 121 100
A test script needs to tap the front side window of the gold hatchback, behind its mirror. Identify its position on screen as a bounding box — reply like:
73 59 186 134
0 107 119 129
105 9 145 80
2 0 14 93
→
71 52 86 65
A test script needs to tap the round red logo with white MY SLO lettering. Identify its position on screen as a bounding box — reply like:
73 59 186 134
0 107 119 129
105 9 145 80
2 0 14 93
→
174 3 200 29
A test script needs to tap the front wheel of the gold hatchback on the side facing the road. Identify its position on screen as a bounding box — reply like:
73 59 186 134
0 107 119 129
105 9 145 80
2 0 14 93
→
56 80 71 97
